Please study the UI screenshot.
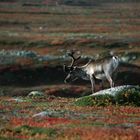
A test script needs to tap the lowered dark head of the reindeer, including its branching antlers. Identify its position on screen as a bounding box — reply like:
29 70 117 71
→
63 51 81 83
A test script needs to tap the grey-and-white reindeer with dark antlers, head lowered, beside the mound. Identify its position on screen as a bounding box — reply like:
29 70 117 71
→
63 51 120 93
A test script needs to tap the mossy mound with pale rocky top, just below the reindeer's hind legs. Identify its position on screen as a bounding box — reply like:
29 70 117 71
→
75 86 140 106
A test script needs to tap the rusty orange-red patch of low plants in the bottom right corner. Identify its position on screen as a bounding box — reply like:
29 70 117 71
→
61 128 140 140
